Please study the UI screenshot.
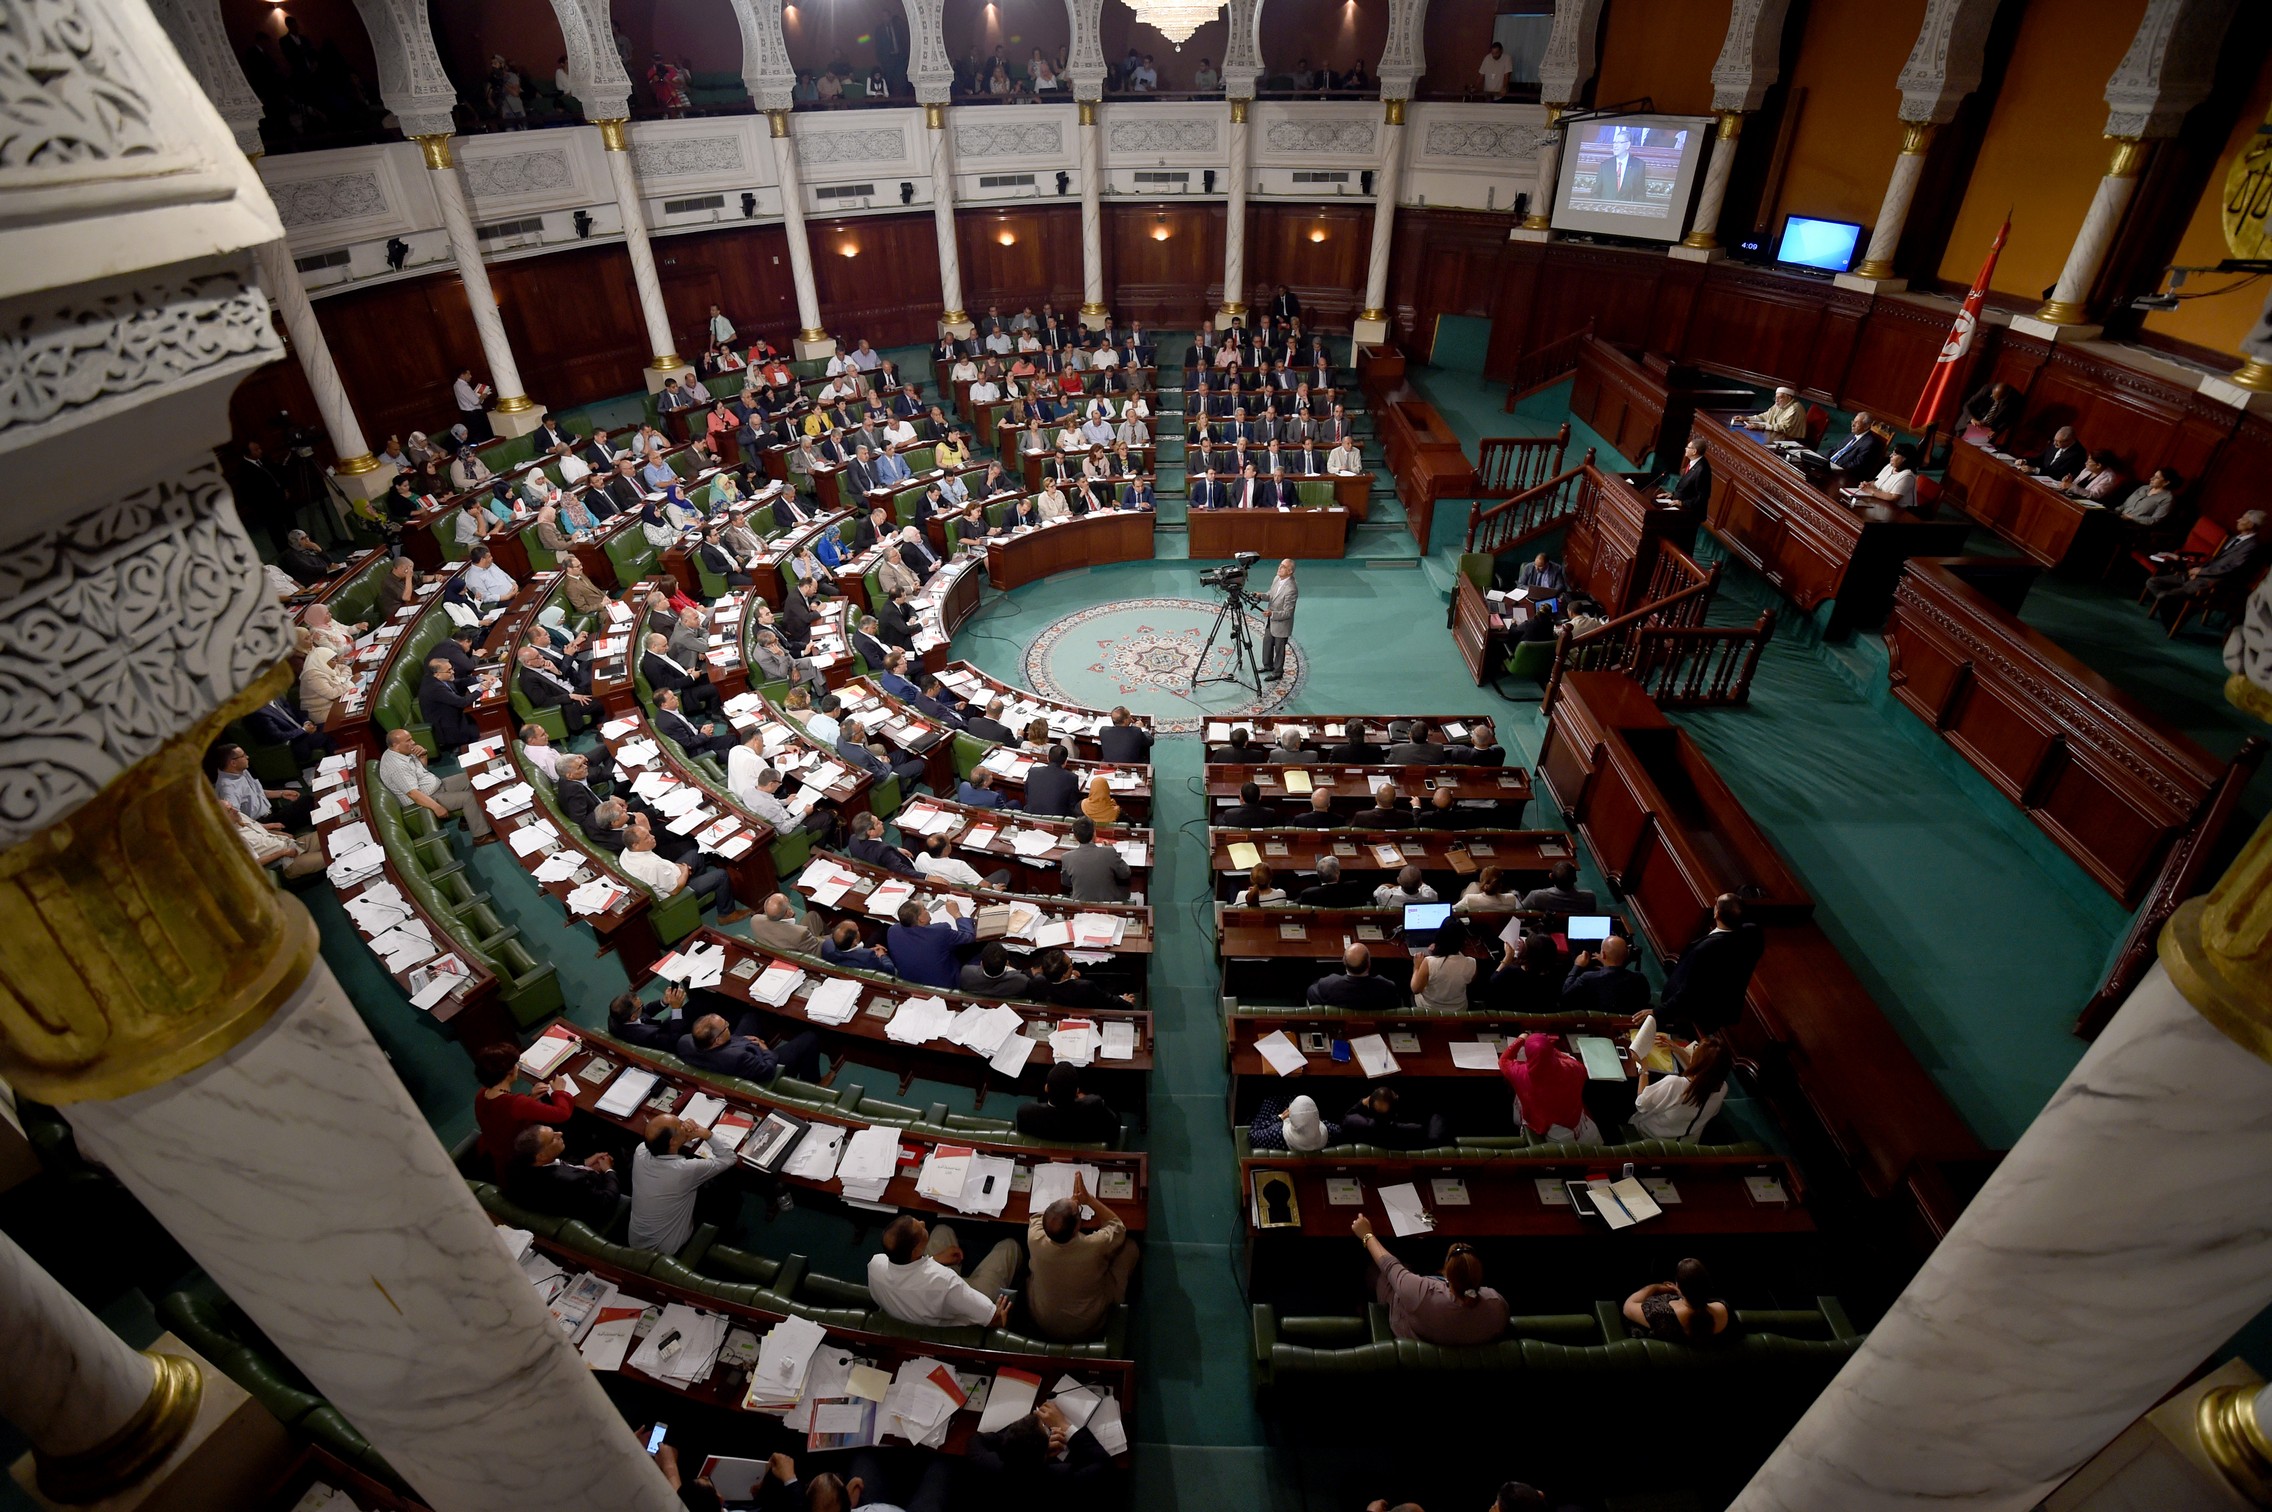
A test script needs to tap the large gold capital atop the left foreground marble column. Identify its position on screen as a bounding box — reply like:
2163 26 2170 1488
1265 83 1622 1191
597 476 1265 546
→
0 662 316 1105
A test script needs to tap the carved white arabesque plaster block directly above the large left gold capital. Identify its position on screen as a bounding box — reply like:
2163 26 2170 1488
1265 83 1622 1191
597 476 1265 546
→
0 463 291 848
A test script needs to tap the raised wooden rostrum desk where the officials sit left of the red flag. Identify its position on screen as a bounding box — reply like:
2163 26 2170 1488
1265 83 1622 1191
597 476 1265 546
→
1695 412 1970 639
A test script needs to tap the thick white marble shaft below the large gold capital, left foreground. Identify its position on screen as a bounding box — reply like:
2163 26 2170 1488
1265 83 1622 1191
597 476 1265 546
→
66 959 679 1512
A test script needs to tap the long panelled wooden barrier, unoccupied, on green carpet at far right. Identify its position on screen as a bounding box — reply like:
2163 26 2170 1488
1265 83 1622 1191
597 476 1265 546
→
1886 559 2224 907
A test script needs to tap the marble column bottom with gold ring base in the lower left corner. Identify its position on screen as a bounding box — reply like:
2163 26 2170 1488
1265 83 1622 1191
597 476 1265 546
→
0 1235 204 1503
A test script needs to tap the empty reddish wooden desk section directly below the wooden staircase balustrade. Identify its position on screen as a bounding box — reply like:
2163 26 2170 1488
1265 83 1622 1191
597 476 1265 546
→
1538 673 1815 959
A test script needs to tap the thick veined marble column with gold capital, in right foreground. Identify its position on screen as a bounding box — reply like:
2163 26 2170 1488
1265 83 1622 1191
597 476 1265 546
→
1734 800 2272 1512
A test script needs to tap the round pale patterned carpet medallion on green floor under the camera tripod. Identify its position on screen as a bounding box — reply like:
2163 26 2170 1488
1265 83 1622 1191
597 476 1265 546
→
1025 598 1306 734
